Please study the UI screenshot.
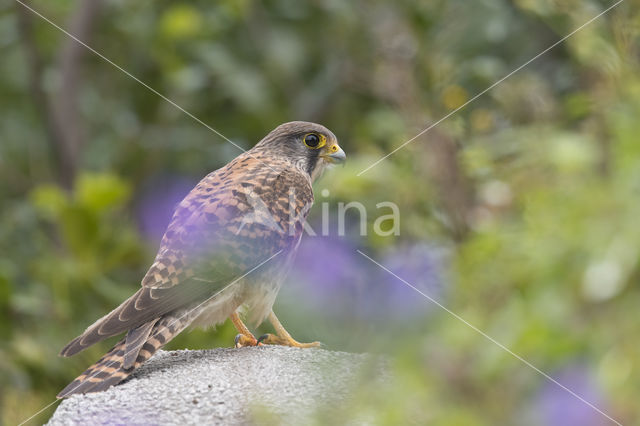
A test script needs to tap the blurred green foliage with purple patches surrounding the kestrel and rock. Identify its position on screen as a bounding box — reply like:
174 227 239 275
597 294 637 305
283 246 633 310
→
0 0 640 425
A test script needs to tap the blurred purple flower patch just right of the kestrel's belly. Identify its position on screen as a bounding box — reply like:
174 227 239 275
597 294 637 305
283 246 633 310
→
289 240 444 322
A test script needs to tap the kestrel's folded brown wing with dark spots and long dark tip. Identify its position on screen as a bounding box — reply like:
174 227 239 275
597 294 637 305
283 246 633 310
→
61 157 313 356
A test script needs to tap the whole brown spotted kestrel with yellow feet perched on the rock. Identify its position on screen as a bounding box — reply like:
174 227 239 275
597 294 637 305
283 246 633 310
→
57 121 346 398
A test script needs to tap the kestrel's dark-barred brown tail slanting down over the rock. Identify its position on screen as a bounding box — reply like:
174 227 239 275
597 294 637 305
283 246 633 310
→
57 315 189 398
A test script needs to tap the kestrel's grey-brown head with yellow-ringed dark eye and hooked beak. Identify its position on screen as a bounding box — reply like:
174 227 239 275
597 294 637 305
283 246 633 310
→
254 121 346 181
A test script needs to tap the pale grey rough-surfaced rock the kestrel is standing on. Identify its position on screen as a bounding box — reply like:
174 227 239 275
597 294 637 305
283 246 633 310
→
48 346 377 425
